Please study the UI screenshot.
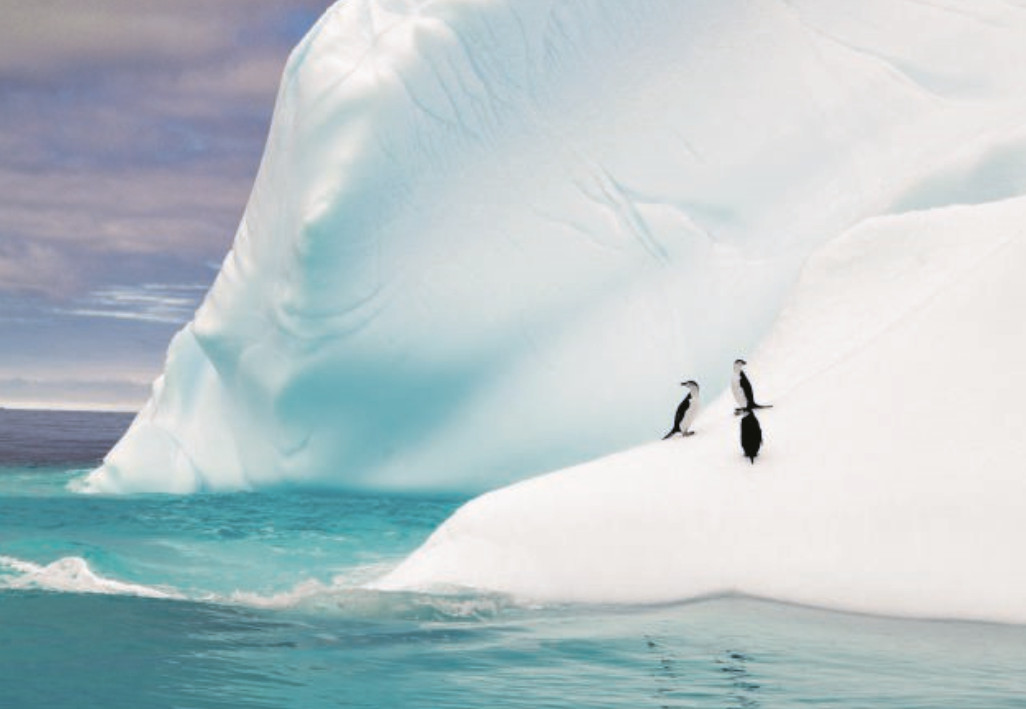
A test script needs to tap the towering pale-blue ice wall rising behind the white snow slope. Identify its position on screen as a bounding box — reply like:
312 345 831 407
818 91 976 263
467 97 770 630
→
87 0 1026 491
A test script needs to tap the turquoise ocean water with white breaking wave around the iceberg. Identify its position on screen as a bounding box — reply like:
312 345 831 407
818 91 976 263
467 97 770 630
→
0 410 1026 709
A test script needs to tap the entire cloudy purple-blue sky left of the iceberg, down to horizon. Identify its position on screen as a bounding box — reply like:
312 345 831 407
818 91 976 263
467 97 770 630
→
0 0 331 410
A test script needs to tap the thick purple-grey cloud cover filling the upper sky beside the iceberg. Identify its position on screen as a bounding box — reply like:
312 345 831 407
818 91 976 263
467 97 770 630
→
0 0 328 277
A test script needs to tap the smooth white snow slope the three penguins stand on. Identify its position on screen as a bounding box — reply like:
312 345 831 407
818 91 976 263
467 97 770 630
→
379 198 1026 623
